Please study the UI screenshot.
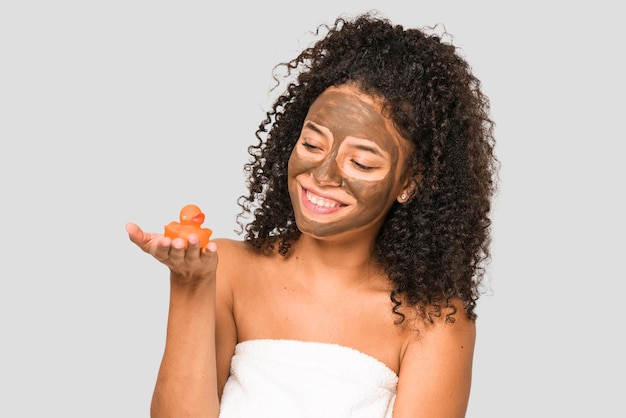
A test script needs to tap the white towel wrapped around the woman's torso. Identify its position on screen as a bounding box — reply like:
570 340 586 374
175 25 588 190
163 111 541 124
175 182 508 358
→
220 340 398 418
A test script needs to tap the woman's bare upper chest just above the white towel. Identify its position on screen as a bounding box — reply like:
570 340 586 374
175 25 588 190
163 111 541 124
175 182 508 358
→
233 264 407 373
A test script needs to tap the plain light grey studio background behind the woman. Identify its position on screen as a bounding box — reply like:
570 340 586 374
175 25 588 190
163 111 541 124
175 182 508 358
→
0 0 626 418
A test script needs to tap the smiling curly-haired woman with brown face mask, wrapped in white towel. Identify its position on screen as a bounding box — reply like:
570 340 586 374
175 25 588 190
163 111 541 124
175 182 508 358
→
127 10 496 418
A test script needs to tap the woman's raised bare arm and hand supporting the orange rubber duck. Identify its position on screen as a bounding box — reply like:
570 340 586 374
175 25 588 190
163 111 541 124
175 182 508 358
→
126 224 219 418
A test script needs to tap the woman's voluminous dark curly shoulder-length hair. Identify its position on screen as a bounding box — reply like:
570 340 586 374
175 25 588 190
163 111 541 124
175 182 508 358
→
239 10 497 322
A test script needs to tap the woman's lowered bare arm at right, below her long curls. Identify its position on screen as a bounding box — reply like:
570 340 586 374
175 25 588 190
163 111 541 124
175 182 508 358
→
393 304 476 418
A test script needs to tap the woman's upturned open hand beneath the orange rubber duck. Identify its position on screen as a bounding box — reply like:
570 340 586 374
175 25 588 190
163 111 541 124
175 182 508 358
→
126 223 217 283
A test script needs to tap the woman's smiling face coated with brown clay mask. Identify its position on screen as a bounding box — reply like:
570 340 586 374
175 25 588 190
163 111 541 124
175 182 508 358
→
288 85 411 242
